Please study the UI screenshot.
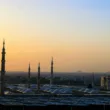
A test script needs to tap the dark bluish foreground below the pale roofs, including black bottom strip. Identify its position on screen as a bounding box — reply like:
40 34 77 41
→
0 95 110 110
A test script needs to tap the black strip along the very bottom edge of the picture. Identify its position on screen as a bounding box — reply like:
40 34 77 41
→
0 105 110 110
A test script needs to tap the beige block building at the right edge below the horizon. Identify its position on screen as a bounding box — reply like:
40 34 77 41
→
101 76 110 90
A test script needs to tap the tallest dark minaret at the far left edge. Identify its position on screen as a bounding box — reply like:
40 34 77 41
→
1 40 6 96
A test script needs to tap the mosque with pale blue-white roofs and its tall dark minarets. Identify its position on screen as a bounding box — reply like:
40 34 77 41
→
0 40 97 96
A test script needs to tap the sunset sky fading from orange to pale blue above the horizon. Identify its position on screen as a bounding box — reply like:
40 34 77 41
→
0 0 110 72
